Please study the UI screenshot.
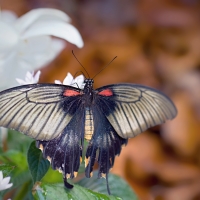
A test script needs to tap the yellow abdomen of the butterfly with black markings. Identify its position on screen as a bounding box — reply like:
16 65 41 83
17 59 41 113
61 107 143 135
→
84 107 94 140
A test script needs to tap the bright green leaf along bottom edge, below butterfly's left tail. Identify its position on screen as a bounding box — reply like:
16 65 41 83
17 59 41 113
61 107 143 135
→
33 182 122 200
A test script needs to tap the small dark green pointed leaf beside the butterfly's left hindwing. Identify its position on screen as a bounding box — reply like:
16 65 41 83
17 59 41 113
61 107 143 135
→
28 141 50 183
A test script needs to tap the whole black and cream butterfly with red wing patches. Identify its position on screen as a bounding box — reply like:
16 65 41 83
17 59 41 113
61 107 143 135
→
0 79 177 193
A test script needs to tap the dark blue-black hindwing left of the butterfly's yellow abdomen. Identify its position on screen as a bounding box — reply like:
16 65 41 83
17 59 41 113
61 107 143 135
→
36 106 85 187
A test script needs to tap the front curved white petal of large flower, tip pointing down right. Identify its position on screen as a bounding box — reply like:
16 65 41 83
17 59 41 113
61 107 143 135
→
21 19 83 48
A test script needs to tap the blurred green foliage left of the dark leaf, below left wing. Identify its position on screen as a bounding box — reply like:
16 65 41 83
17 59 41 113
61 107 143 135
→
0 131 33 200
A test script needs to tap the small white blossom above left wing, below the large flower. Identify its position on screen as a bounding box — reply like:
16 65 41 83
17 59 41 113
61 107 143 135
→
16 71 41 85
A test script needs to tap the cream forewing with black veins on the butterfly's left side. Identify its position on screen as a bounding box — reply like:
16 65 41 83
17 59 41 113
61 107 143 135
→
0 84 81 140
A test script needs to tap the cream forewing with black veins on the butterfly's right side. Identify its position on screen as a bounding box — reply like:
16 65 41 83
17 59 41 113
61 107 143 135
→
95 84 177 138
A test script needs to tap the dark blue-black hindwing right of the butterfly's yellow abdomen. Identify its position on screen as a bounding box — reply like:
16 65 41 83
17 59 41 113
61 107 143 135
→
85 105 127 178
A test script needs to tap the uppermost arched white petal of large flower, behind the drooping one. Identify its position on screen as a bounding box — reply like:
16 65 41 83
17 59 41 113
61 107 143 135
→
15 8 70 33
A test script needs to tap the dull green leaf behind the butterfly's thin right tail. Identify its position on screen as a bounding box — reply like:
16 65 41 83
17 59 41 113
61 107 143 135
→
78 171 137 200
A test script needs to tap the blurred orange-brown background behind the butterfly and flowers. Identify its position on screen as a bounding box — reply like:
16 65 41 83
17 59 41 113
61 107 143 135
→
1 0 200 200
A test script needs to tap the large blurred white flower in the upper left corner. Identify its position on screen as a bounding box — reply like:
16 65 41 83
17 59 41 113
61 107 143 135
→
0 8 83 90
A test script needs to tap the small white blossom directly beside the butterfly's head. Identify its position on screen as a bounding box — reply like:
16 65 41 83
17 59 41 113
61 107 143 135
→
55 73 84 89
